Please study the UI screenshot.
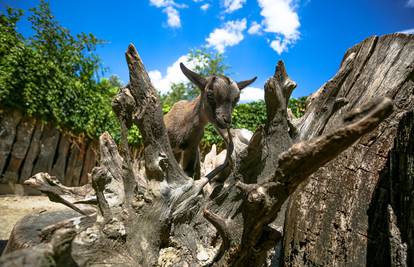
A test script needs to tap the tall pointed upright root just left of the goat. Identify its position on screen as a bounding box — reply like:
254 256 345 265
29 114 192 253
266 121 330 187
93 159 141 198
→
125 44 190 184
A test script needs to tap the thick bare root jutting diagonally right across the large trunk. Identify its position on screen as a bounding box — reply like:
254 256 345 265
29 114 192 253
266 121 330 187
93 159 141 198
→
273 98 393 193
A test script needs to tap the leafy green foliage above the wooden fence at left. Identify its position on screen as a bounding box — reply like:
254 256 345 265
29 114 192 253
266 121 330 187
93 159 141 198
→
0 1 120 137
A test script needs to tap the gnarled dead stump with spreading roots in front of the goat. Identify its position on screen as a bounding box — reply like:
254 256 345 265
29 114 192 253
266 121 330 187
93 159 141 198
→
1 34 404 266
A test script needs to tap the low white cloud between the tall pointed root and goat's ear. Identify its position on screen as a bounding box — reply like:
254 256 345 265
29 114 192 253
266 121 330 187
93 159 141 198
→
148 55 206 94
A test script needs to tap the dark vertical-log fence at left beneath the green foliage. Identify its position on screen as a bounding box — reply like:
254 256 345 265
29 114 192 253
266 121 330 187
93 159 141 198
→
0 109 98 195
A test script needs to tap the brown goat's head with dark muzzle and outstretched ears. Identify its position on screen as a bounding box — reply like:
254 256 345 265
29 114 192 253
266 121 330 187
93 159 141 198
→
180 63 257 129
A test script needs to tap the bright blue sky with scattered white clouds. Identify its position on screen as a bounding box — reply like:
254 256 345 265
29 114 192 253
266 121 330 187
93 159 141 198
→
0 0 414 102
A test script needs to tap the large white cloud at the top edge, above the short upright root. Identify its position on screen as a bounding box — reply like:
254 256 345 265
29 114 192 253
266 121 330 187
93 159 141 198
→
258 0 300 54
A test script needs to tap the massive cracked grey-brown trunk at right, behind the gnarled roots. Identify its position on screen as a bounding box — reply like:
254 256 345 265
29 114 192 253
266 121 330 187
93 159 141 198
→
284 34 414 266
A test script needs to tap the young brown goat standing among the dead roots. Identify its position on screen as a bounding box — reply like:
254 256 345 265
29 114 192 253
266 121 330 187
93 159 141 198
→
164 63 257 178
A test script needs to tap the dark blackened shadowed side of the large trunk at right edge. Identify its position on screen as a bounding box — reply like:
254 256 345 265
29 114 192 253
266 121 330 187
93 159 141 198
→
364 111 414 266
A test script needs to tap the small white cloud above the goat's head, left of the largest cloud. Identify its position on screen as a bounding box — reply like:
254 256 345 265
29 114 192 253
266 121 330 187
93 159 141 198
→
206 19 246 53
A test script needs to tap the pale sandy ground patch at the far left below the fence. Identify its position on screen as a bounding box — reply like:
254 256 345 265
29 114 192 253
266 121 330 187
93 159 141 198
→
0 195 66 255
